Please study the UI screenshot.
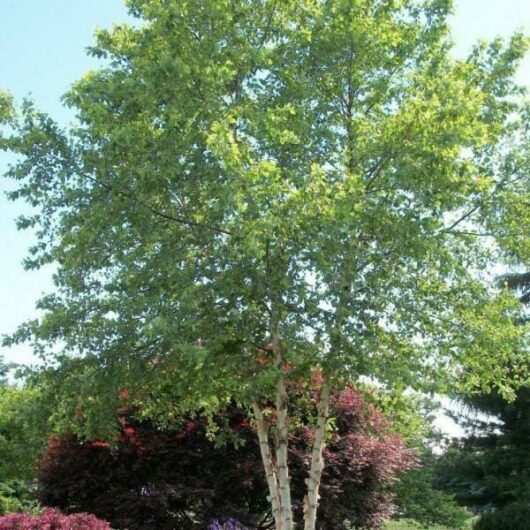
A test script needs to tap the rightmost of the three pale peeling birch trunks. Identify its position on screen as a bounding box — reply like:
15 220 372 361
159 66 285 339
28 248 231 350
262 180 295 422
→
304 382 330 530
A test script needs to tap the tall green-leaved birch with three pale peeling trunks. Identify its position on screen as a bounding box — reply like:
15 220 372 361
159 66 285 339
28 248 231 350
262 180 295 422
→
2 0 528 530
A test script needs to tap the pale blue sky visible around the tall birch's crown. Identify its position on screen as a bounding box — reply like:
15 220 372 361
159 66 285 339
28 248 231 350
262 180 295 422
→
0 0 530 368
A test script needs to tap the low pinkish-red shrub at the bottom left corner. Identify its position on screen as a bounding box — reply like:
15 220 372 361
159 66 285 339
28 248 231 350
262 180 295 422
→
0 510 110 530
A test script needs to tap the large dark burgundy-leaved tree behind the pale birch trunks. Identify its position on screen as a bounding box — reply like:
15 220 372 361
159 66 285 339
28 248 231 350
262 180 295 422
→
38 390 415 530
